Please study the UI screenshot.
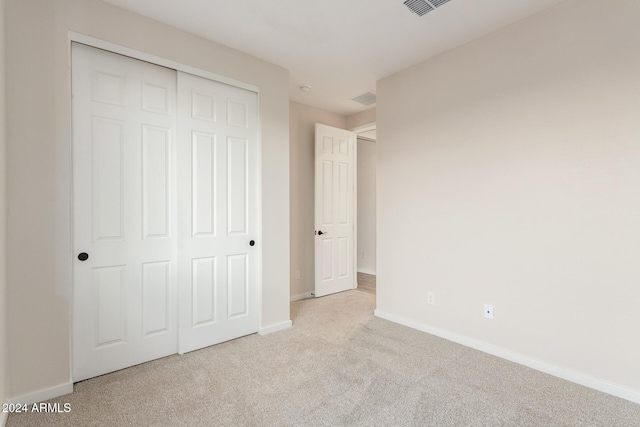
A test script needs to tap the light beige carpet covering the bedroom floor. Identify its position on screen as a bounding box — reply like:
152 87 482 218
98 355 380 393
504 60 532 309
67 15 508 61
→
8 291 640 427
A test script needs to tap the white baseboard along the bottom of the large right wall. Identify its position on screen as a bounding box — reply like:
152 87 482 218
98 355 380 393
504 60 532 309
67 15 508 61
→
374 310 640 403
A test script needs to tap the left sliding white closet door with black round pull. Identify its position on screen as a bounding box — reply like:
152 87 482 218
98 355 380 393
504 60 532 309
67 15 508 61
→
72 44 177 381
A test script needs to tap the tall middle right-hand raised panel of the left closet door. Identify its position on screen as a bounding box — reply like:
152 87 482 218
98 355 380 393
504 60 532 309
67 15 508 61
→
142 125 170 239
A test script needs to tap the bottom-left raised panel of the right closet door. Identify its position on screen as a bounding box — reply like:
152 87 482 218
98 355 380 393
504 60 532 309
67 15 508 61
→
191 257 217 327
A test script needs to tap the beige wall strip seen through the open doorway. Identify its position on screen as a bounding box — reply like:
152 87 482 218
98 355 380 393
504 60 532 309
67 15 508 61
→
357 139 376 274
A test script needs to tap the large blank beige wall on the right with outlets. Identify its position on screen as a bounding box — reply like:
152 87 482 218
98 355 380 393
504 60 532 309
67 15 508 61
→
377 0 640 397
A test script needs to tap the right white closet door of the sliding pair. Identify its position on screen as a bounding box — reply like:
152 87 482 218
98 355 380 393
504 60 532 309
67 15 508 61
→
178 72 262 353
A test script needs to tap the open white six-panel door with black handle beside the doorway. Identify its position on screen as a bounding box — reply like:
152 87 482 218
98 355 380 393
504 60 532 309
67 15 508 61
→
315 124 357 297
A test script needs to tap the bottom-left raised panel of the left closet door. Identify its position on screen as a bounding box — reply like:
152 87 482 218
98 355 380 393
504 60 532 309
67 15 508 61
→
92 265 127 348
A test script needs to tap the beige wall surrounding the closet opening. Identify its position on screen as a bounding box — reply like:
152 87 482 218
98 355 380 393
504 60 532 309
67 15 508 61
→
6 0 289 397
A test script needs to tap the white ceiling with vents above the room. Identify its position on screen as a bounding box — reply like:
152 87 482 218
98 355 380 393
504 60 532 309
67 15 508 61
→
100 0 562 114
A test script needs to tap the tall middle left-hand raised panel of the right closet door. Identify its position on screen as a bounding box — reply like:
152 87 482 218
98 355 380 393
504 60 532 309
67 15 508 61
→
191 132 217 236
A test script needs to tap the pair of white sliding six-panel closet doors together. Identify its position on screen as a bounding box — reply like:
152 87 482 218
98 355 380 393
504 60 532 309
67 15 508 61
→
72 43 260 381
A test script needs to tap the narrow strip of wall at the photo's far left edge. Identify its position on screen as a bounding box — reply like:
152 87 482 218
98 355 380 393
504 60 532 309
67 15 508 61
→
0 0 9 412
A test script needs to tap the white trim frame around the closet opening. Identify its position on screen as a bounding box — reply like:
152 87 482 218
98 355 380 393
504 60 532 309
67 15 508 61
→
67 31 263 384
